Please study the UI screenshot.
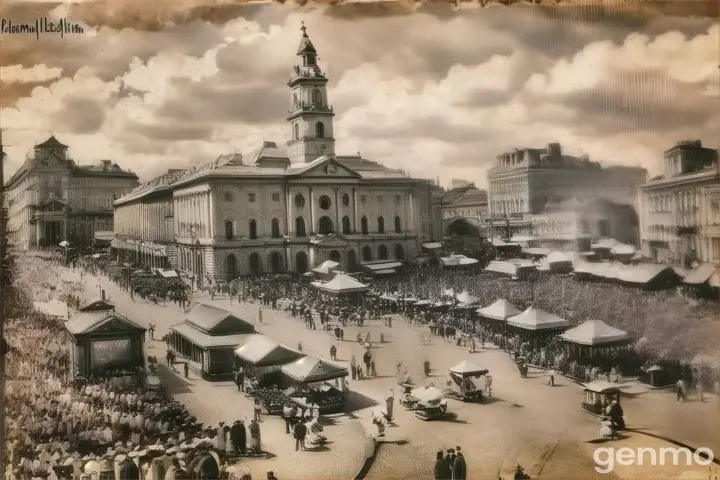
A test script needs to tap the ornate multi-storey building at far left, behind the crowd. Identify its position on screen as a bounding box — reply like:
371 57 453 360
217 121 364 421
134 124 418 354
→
5 136 138 248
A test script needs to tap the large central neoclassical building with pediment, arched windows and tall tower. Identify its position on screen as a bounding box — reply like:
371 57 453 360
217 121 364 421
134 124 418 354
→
113 27 442 279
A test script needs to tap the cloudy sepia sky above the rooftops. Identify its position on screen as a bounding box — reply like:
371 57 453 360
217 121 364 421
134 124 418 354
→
0 0 720 185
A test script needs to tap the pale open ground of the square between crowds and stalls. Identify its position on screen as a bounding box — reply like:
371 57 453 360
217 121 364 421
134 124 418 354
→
80 277 720 480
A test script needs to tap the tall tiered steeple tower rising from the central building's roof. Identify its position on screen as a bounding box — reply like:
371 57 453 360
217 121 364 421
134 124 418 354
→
287 24 335 163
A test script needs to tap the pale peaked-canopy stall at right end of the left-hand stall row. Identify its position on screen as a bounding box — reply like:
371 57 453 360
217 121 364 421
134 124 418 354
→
280 355 349 413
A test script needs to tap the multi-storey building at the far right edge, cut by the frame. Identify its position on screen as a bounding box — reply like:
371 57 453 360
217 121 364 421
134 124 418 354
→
638 140 720 266
